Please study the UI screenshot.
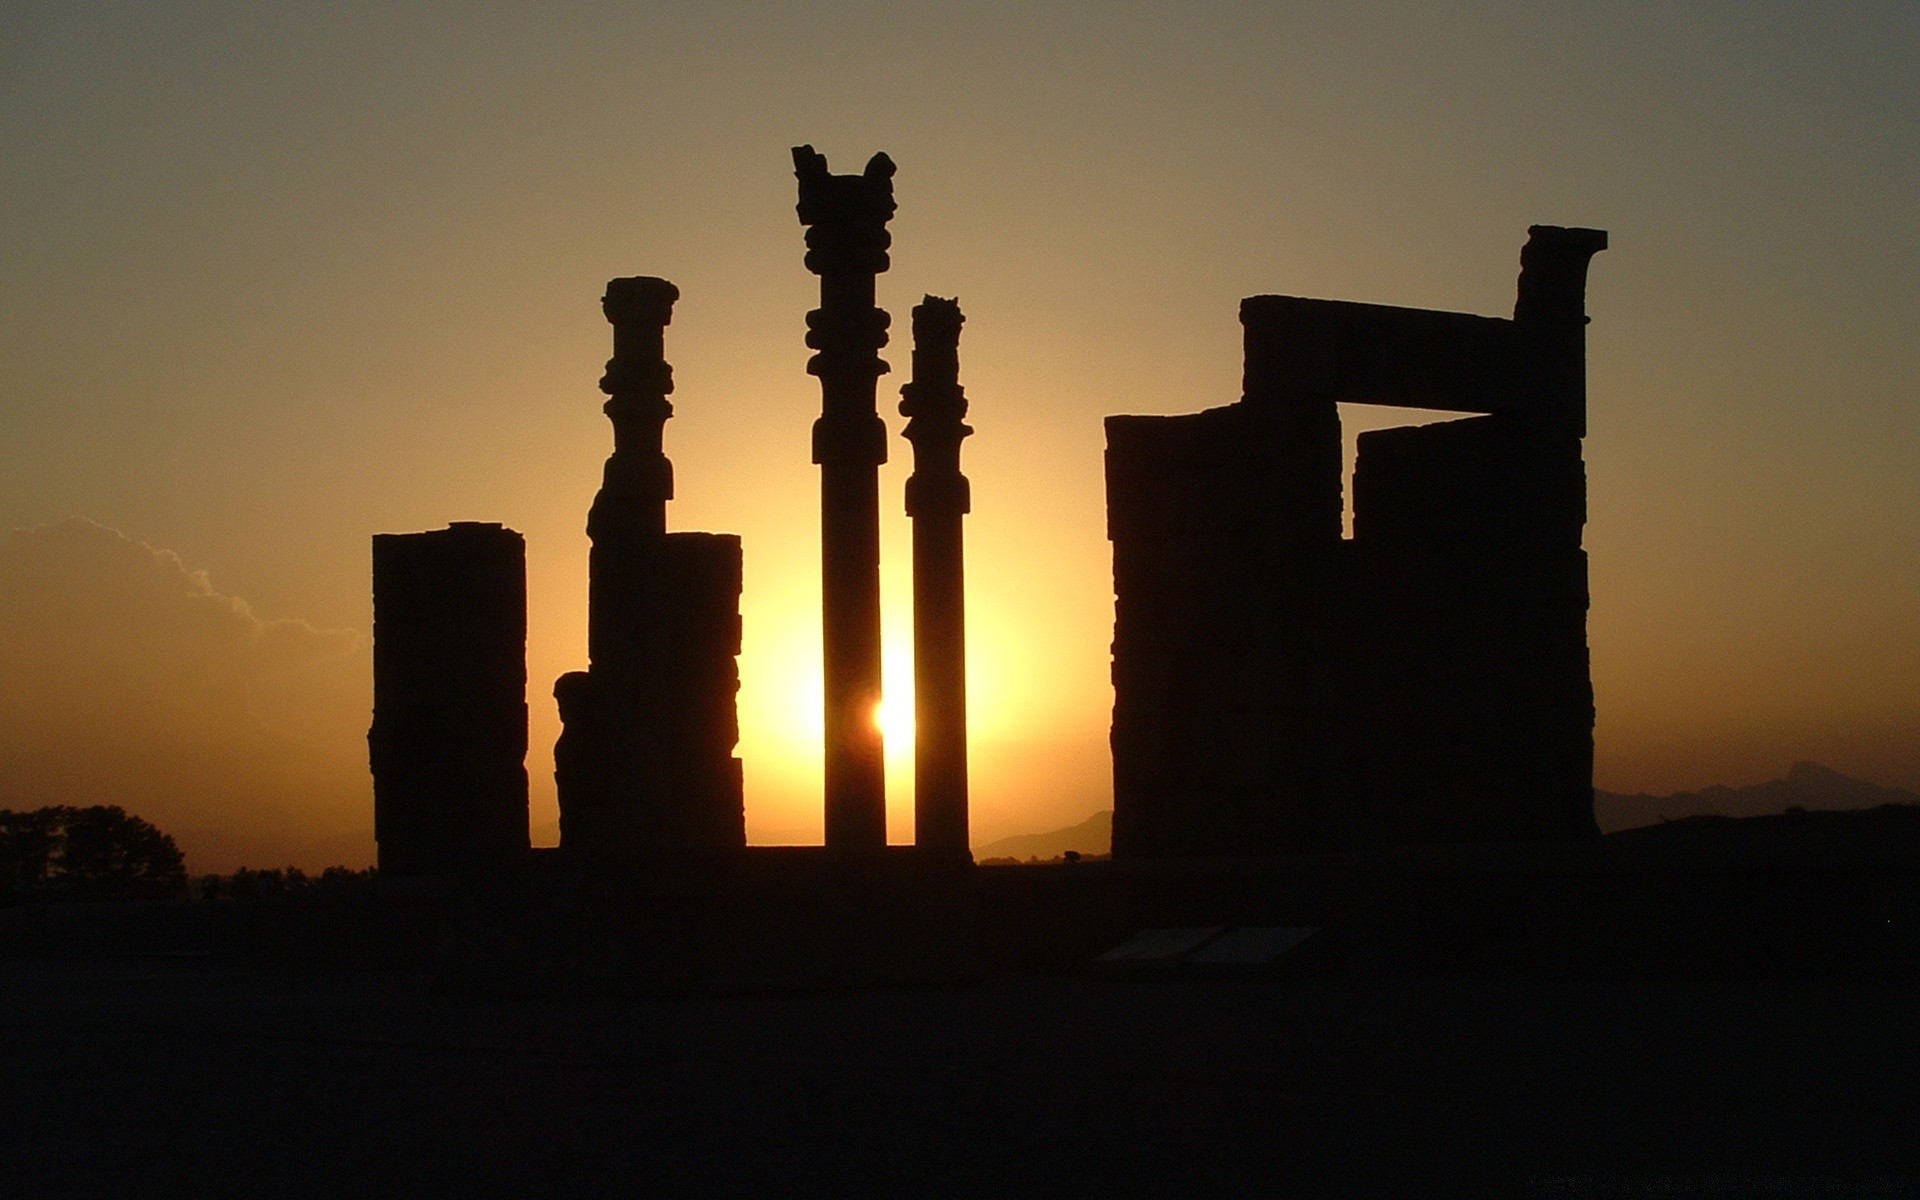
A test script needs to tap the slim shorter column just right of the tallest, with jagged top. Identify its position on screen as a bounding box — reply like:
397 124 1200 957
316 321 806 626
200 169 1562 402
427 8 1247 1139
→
900 296 973 856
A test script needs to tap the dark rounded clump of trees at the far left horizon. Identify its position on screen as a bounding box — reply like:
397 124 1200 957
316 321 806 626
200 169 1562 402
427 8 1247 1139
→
0 804 186 899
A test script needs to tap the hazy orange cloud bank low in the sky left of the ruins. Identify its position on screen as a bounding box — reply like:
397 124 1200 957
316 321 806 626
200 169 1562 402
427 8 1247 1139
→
0 518 371 870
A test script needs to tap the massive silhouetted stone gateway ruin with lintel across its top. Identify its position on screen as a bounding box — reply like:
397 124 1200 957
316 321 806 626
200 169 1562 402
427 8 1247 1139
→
1106 227 1607 858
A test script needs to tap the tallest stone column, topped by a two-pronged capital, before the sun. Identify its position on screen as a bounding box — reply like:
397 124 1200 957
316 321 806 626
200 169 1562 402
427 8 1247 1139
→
793 146 893 852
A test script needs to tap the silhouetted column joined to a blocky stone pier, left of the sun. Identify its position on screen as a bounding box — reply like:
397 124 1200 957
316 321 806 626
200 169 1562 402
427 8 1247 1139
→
553 276 747 852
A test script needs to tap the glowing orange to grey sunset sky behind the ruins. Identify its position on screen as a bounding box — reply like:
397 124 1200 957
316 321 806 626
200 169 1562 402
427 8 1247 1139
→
0 0 1920 870
